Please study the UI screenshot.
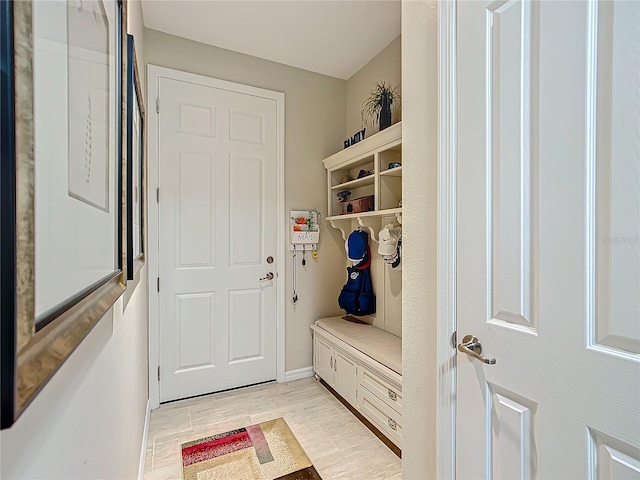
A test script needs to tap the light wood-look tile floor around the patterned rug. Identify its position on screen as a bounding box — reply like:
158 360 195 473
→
145 378 402 480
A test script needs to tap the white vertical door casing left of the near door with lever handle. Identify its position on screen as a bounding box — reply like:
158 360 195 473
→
436 1 457 478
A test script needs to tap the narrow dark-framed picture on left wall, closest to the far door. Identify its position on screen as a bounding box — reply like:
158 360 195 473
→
127 35 146 280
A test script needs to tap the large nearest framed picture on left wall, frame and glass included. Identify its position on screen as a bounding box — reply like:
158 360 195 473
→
0 0 127 428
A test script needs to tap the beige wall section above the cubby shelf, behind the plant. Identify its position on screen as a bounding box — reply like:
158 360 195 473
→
345 36 402 138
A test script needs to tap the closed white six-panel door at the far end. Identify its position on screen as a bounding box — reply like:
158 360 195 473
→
158 78 277 401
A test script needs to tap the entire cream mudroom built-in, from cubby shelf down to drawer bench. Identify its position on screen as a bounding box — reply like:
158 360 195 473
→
311 122 402 454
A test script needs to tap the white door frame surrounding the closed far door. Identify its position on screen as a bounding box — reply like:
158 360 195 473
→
147 64 287 409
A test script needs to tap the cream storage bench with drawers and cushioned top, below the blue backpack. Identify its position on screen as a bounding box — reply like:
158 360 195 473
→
311 317 402 449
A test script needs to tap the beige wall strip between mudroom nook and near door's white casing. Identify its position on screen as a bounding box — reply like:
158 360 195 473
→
402 0 438 480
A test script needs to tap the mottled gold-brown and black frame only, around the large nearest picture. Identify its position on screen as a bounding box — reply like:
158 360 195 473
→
0 0 127 429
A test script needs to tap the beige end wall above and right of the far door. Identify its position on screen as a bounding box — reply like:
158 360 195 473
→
144 29 346 371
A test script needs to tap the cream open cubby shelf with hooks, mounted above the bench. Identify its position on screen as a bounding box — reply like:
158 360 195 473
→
323 122 402 242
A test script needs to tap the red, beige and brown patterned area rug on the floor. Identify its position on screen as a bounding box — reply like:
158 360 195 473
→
182 418 320 480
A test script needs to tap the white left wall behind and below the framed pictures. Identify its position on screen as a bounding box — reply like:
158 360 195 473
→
0 0 148 480
